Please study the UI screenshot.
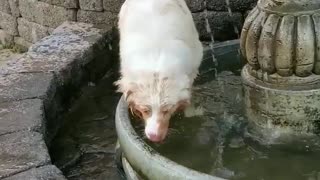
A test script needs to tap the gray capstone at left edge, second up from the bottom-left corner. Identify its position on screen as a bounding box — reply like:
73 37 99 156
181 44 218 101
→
0 131 50 178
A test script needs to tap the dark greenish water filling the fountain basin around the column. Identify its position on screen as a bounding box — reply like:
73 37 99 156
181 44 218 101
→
133 44 320 180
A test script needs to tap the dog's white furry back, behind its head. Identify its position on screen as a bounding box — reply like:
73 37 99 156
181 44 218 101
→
119 0 202 79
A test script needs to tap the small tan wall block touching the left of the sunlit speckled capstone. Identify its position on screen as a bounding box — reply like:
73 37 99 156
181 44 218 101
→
18 18 49 43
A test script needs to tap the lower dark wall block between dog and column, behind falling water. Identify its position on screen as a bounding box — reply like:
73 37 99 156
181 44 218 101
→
193 11 243 41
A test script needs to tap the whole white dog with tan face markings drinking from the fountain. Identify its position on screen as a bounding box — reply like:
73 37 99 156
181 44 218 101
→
116 0 203 142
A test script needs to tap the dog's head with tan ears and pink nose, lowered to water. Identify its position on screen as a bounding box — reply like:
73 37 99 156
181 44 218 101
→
116 74 191 142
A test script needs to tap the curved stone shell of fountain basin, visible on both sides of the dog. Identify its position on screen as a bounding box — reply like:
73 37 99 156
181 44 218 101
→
116 40 239 180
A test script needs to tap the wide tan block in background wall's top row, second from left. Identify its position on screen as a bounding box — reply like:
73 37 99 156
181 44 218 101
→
19 0 76 28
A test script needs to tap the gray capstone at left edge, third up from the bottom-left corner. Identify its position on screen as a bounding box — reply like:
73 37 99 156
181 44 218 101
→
0 99 44 136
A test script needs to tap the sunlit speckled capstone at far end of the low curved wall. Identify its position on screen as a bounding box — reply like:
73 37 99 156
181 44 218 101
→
0 22 107 76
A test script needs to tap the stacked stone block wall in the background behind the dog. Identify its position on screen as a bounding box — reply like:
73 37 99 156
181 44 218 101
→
0 0 256 47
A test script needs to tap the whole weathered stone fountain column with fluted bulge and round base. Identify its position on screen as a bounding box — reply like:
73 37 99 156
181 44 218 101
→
241 0 320 133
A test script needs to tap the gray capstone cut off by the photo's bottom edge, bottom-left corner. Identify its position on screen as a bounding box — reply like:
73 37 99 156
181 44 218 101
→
4 165 66 180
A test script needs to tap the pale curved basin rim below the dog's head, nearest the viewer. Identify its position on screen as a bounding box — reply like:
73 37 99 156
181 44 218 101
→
116 97 224 180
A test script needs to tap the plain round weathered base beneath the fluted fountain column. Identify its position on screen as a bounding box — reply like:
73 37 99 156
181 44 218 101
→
242 65 320 133
